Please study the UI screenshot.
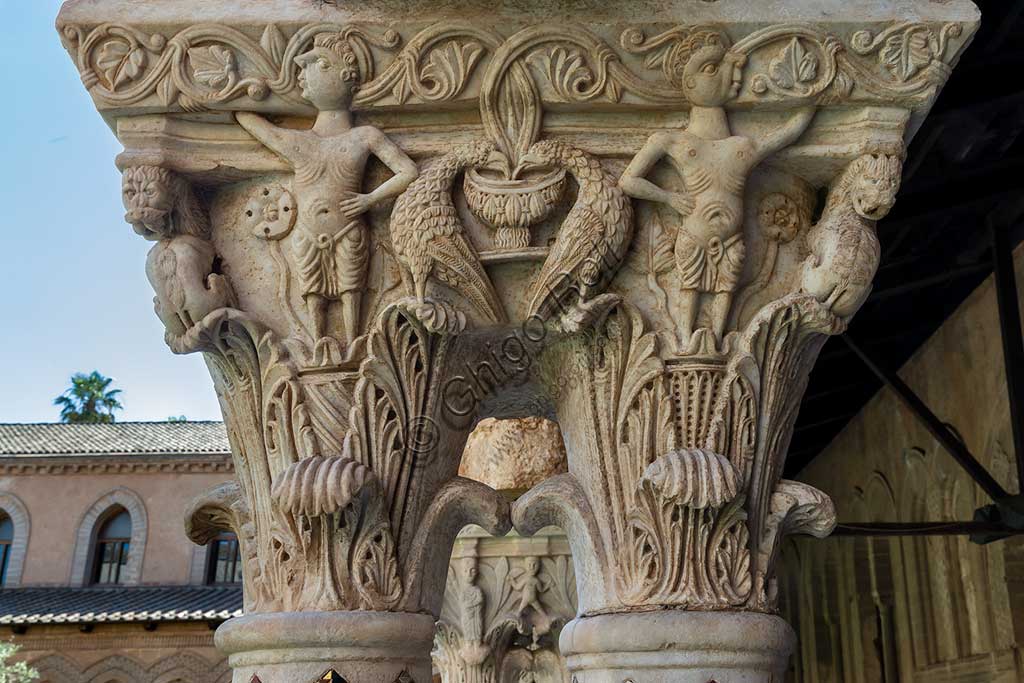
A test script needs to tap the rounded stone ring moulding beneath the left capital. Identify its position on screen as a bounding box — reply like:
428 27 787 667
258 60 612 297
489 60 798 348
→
215 611 434 683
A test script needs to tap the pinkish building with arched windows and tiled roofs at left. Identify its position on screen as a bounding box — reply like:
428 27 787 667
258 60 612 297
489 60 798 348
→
0 422 242 683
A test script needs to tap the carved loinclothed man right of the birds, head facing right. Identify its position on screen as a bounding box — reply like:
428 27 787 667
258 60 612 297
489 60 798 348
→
620 31 814 348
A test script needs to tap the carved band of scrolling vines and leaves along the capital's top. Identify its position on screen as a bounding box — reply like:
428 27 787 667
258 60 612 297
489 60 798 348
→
60 20 963 117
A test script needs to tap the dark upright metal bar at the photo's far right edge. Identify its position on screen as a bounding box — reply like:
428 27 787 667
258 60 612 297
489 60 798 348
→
988 219 1024 492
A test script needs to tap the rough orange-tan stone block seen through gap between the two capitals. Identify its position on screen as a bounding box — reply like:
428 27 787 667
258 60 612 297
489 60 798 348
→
459 418 566 492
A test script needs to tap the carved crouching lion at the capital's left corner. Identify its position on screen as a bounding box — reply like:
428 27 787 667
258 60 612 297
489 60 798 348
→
121 166 234 348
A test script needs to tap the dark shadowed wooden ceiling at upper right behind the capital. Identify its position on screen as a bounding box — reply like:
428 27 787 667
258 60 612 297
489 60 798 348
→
785 0 1024 476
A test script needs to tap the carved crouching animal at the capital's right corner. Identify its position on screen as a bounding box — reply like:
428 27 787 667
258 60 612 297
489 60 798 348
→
800 155 902 317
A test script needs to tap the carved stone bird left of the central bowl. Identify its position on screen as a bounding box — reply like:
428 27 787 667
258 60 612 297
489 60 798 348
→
390 141 506 323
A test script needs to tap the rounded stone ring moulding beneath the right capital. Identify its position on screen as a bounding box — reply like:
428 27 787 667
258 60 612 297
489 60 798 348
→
559 610 797 683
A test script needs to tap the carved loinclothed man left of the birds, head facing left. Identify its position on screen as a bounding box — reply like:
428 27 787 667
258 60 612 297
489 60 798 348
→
236 33 417 346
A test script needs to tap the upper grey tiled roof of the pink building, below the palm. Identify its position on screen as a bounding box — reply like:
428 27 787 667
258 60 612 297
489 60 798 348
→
0 422 230 457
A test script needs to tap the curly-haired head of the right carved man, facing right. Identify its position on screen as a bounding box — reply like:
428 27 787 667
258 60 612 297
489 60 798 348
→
670 30 746 106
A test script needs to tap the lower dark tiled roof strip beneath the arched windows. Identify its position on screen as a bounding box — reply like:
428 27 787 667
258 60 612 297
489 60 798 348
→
0 586 242 626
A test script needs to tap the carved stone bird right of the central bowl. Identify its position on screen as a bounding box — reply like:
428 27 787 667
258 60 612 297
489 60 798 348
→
519 140 633 319
